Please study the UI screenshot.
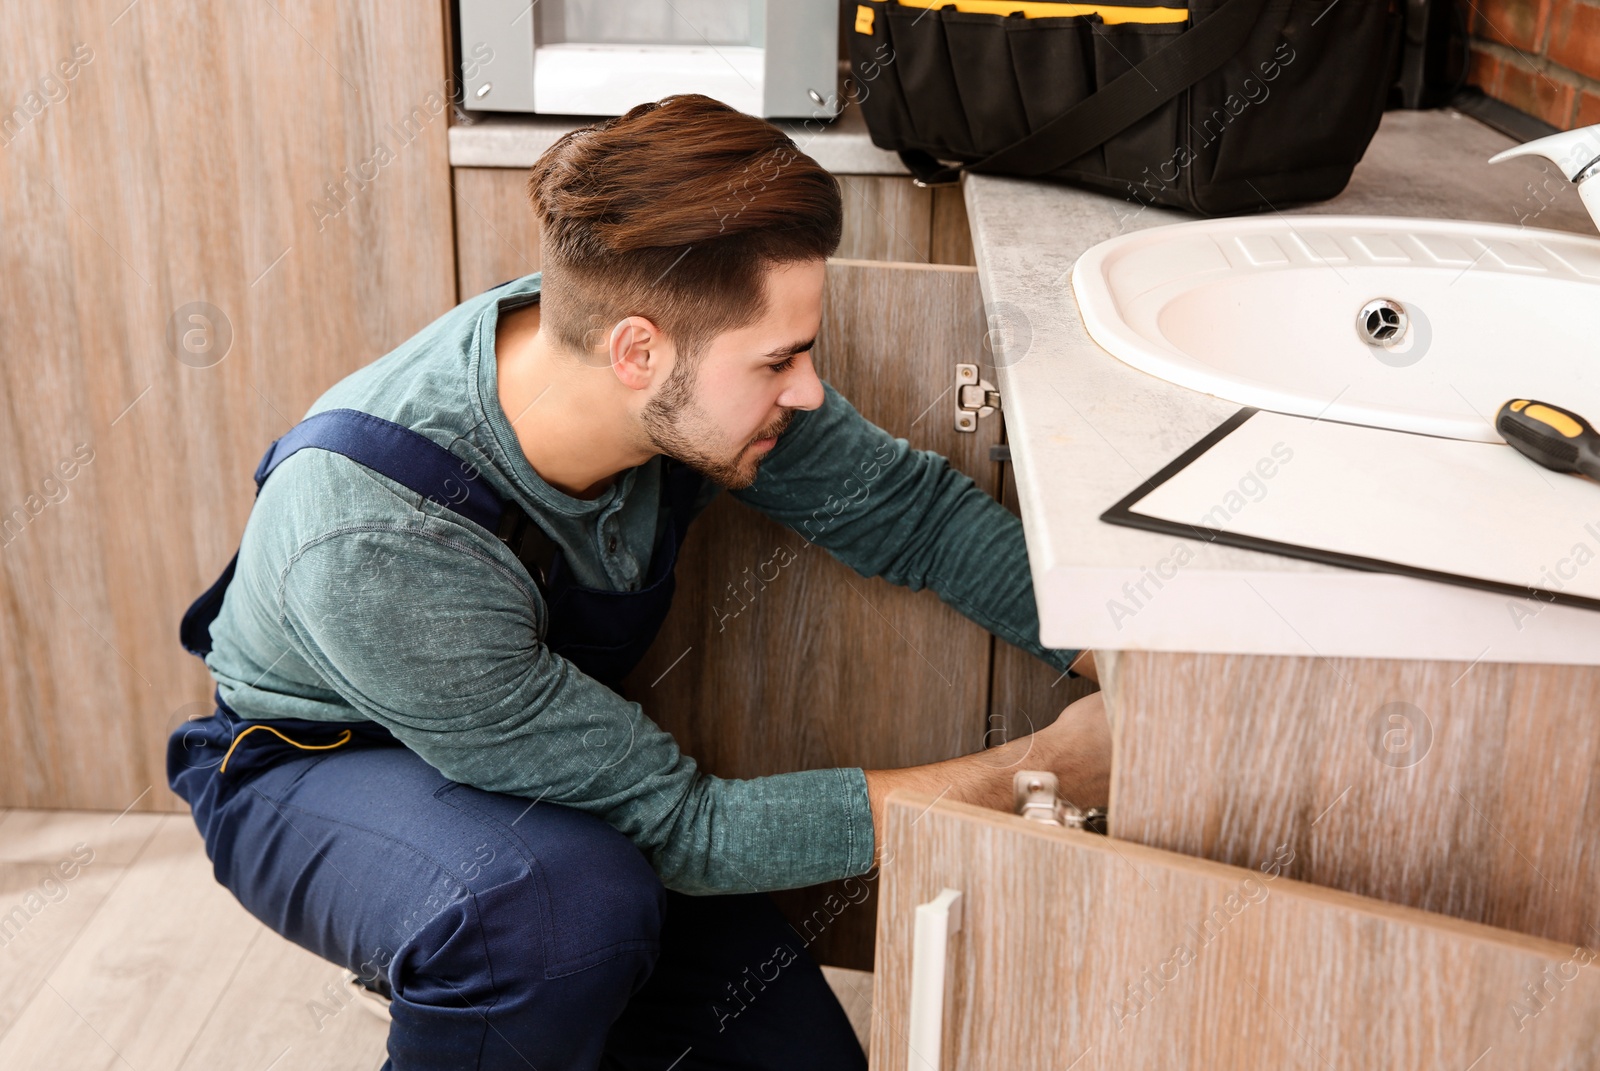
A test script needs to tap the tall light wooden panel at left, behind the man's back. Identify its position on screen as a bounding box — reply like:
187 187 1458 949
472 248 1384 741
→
0 0 456 810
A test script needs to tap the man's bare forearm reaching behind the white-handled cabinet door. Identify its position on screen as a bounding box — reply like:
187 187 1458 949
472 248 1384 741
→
866 692 1110 863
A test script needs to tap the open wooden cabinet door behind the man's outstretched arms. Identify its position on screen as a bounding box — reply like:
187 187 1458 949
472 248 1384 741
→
624 261 998 969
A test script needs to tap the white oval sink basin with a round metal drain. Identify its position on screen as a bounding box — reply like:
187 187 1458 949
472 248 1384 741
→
1072 215 1600 442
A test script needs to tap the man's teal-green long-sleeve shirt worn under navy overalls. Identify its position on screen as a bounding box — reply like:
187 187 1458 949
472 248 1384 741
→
196 274 1077 893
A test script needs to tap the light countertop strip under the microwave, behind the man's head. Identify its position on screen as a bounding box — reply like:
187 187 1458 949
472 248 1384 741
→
450 98 907 174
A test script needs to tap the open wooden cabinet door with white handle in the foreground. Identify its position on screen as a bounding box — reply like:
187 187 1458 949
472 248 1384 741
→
872 794 1600 1071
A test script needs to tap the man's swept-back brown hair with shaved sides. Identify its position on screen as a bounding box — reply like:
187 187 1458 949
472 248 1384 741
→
528 93 842 360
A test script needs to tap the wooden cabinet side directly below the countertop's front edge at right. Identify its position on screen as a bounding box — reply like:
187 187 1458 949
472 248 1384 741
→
1096 652 1600 943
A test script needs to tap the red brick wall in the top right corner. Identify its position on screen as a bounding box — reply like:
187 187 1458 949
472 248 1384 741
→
1459 0 1600 130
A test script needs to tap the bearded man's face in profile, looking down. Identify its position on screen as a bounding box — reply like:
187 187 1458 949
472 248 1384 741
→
640 261 824 490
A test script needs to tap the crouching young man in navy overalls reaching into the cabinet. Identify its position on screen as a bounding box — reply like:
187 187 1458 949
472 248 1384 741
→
168 96 1109 1071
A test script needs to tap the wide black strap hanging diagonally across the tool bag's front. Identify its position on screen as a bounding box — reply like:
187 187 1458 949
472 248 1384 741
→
899 0 1267 186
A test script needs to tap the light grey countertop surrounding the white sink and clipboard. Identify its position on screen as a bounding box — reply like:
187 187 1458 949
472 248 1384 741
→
963 109 1600 664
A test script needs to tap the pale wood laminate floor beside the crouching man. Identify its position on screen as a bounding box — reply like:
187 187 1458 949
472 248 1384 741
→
0 810 872 1071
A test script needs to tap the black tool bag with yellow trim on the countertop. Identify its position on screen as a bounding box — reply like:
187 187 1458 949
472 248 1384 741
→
846 0 1405 216
